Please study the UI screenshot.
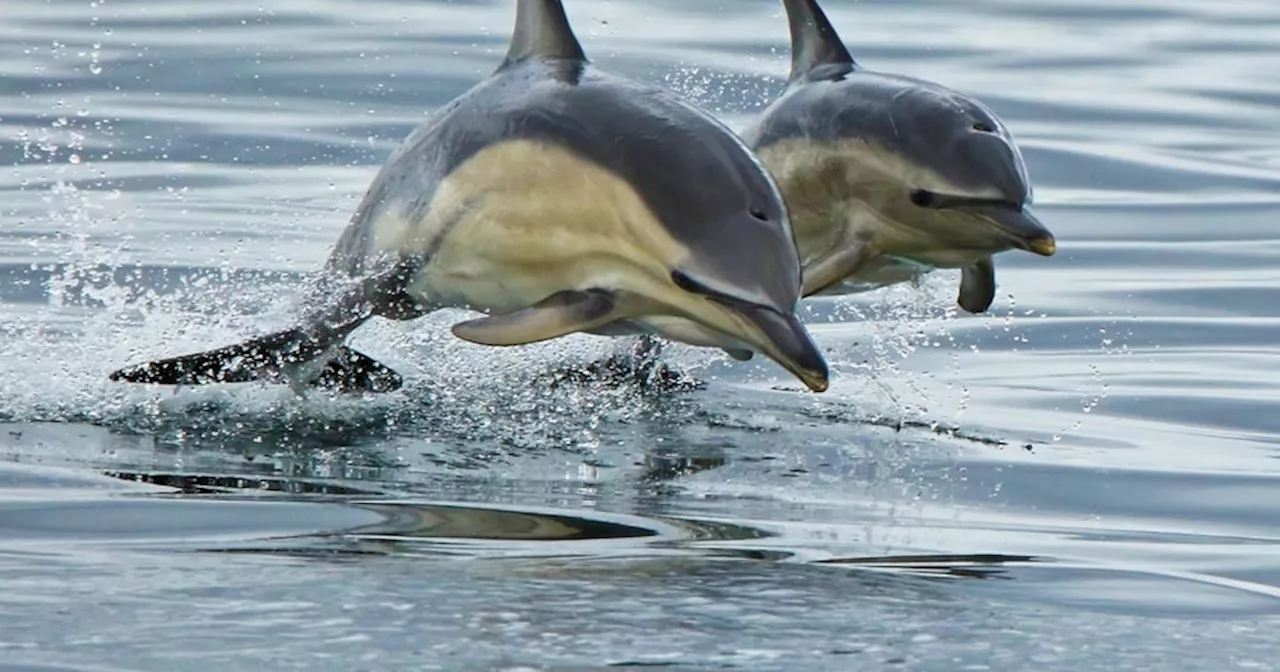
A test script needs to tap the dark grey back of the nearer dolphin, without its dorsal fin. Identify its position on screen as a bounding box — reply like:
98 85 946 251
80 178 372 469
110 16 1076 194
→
340 59 800 308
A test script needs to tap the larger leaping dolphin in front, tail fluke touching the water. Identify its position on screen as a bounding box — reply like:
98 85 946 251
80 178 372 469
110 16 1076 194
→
110 0 828 392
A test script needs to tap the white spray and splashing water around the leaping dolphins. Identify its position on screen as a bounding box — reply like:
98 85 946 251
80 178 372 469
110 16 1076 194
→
0 23 1090 488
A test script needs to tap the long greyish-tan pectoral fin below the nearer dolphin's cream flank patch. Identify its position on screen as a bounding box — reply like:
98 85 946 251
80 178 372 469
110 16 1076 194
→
453 289 643 346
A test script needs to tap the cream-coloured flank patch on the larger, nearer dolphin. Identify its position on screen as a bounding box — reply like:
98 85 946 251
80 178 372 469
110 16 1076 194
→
375 140 689 312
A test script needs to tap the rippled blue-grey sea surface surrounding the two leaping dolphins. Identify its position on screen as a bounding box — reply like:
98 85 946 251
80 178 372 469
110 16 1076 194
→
0 0 1280 671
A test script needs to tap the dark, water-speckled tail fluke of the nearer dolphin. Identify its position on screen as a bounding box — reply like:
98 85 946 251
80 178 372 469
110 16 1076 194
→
110 329 403 392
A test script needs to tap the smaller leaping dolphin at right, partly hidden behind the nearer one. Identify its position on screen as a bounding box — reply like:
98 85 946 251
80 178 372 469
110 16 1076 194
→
741 0 1057 314
